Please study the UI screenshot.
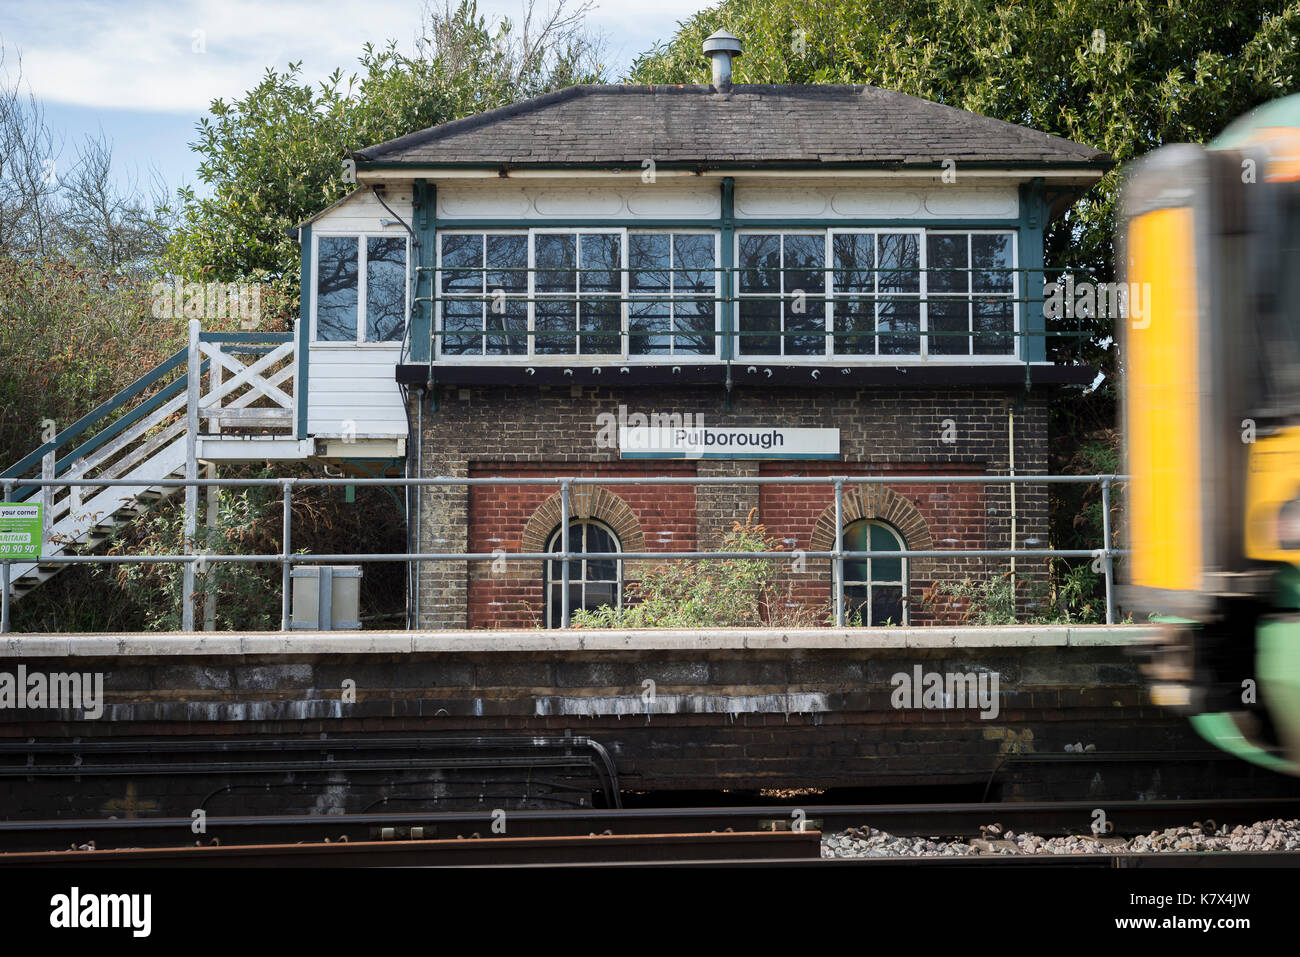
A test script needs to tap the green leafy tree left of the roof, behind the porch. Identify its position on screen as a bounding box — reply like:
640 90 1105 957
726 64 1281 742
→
170 0 602 320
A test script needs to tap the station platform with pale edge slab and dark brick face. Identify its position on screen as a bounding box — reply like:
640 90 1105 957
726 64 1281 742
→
0 625 1296 818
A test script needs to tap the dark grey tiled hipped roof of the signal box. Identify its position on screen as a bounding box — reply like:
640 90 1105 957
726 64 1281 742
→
355 86 1112 169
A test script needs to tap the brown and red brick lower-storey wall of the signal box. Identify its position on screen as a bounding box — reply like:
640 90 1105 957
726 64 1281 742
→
419 386 1048 628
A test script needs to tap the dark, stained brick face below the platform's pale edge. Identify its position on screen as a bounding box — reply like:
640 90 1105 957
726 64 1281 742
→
0 644 1296 818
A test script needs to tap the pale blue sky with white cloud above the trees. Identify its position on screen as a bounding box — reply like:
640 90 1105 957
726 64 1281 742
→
0 0 711 192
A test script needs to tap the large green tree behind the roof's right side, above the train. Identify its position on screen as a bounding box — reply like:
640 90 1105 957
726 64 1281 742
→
629 0 1300 368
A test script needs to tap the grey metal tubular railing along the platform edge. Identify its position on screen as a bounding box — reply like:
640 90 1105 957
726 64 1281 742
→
0 473 1127 633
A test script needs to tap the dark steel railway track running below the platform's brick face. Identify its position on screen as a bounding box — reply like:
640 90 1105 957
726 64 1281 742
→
0 798 1300 866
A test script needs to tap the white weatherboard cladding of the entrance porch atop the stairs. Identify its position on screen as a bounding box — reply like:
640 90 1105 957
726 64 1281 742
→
307 186 411 438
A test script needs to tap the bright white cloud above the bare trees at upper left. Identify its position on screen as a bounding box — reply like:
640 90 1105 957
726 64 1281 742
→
0 0 707 113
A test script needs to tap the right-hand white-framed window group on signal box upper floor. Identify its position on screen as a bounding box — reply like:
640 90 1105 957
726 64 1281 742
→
736 229 1018 358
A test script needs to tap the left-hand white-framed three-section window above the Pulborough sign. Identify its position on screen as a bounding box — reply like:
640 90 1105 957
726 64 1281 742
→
438 229 719 356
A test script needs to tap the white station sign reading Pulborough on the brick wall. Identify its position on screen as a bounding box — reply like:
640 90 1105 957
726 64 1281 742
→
619 425 840 459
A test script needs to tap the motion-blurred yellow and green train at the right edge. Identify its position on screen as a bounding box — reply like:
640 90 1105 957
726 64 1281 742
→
1118 95 1300 775
